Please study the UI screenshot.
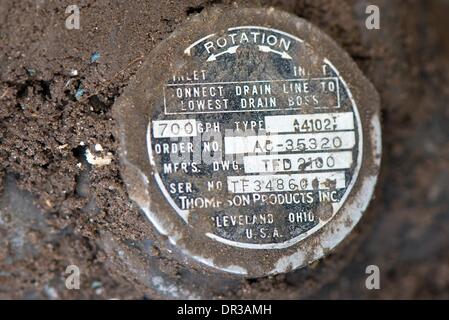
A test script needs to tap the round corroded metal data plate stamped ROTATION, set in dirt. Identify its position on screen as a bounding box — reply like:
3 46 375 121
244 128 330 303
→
114 9 381 277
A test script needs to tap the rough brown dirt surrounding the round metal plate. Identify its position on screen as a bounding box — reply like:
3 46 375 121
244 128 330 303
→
0 0 449 299
